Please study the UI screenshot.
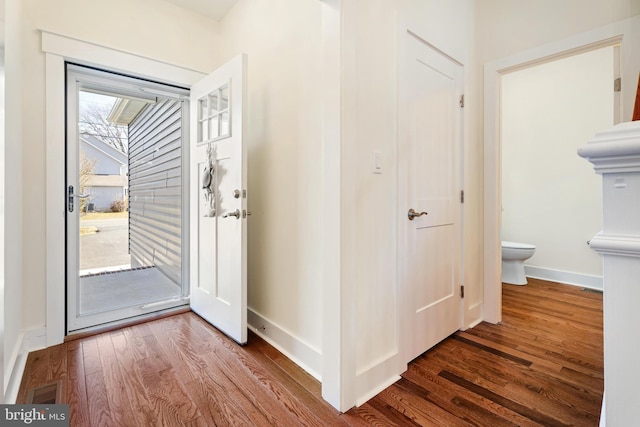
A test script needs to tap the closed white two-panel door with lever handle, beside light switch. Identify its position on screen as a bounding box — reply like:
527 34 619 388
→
398 32 463 361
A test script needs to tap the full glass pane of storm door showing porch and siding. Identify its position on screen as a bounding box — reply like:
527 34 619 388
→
73 82 185 331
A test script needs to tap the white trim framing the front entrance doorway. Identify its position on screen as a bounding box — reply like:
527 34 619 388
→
42 31 205 347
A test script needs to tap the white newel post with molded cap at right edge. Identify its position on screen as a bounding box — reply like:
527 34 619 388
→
578 122 640 427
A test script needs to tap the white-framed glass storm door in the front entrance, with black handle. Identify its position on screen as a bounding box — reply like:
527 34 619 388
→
65 64 189 333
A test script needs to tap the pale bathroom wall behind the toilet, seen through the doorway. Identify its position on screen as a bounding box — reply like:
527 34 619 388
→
501 47 614 286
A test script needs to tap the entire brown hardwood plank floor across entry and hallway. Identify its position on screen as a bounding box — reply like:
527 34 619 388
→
18 279 603 427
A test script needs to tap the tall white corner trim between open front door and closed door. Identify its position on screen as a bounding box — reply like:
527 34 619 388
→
321 0 357 412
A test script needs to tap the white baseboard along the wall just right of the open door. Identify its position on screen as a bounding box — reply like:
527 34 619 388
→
247 308 322 381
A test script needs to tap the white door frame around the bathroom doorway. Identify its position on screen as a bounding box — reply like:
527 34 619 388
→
483 16 640 323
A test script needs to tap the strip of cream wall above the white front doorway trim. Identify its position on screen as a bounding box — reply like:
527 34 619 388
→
23 0 218 72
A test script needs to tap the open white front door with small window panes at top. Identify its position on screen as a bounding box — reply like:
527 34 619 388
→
190 55 248 344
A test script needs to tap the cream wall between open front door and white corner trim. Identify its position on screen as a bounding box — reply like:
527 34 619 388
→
220 0 324 377
